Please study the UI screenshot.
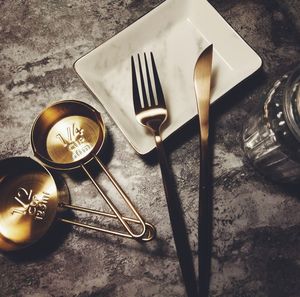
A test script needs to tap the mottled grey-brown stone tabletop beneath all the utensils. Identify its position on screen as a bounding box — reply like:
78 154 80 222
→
0 0 300 297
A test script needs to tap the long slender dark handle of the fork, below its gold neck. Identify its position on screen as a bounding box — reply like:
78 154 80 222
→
154 133 197 297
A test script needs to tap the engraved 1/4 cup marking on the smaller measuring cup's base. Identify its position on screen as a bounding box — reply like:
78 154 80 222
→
56 123 91 160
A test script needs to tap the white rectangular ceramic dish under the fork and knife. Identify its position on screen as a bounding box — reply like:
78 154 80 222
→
74 0 261 154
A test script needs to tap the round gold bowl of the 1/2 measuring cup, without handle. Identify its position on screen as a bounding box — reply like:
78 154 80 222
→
0 157 59 251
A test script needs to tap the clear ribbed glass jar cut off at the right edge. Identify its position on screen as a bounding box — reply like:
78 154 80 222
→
242 65 300 182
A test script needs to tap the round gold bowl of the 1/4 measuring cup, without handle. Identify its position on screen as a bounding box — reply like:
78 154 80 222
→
31 100 105 170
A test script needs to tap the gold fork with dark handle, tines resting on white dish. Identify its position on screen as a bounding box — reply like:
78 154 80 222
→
131 53 197 297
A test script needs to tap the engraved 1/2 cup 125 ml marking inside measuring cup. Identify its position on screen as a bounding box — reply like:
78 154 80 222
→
12 187 50 220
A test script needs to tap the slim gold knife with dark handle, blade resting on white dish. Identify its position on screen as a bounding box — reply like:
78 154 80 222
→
194 45 213 296
